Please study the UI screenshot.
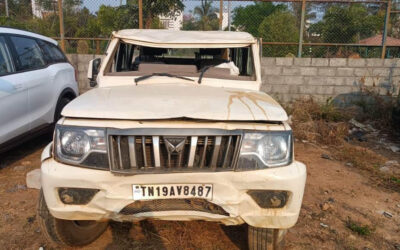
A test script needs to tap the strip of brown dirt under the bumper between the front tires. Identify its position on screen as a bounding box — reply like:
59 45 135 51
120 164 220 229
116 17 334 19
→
105 220 247 249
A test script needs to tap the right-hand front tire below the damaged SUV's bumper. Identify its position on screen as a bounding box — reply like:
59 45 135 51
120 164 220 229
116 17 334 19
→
248 225 286 250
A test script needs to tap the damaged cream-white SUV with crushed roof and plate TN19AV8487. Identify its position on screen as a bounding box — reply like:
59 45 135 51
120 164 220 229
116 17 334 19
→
36 30 306 249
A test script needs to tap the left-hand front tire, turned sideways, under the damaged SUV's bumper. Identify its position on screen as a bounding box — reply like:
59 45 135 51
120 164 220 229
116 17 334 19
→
37 190 108 246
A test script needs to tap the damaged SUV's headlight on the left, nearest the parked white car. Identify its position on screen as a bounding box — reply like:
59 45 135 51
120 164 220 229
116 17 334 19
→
54 125 108 169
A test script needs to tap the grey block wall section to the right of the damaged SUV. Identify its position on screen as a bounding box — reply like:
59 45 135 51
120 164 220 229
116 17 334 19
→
261 57 400 102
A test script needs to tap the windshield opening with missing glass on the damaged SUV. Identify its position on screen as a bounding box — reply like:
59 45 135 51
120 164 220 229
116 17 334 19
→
106 42 255 80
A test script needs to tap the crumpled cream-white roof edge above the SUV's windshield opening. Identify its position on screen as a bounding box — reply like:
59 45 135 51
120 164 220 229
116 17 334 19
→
113 29 257 48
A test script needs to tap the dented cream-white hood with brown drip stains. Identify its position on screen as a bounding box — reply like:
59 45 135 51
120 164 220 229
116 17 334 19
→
62 84 287 121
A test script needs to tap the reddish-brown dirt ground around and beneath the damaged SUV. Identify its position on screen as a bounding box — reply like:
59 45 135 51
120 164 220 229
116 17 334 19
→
0 134 400 250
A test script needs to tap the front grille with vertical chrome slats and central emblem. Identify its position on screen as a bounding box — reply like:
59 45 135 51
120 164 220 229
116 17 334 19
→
108 129 241 173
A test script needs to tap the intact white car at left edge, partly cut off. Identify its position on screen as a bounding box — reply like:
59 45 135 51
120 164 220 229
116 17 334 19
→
0 27 79 152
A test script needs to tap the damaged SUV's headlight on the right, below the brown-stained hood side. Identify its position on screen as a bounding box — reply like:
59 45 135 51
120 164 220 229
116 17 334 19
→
238 131 292 170
